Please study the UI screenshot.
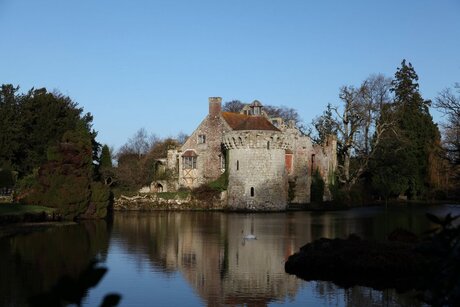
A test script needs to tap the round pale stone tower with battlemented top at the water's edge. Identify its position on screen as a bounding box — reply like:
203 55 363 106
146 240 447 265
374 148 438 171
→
223 130 288 211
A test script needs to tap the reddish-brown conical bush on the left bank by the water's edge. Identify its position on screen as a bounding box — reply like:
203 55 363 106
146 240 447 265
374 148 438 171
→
21 127 110 220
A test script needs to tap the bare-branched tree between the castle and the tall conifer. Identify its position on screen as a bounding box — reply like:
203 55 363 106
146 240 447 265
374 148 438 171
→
313 75 394 192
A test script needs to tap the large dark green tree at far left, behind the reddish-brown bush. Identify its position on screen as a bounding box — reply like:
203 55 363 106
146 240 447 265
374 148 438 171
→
0 84 99 178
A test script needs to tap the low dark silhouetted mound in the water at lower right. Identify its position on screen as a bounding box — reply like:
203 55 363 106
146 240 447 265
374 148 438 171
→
285 235 432 291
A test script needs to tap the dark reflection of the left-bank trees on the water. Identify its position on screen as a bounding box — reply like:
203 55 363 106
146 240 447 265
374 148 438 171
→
0 221 109 306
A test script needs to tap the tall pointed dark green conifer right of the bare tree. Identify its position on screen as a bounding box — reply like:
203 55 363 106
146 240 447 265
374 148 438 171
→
373 60 441 198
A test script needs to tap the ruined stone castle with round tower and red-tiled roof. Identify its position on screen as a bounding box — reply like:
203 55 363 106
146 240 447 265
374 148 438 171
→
151 97 337 211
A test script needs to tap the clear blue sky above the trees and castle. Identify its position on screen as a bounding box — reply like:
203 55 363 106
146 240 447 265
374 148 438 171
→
0 0 460 149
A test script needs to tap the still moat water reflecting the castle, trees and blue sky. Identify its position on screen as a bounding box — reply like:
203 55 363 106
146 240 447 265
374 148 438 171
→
0 205 460 306
